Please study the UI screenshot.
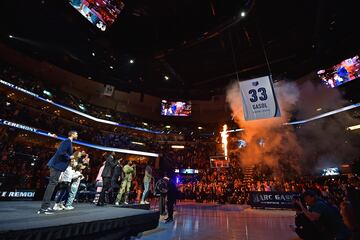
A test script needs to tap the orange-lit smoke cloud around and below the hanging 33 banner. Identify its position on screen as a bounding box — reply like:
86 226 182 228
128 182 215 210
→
227 82 302 175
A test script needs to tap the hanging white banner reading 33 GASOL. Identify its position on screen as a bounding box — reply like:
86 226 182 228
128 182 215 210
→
239 76 280 120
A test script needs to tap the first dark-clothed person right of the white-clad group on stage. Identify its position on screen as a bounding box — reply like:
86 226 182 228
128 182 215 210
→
96 152 117 206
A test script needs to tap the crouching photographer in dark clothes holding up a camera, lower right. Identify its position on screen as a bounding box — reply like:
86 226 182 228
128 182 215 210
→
295 190 350 240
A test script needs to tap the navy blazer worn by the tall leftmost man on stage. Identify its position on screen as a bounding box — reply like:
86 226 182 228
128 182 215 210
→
48 139 73 172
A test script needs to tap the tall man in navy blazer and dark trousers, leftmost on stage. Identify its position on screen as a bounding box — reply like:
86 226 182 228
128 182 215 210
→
38 131 78 214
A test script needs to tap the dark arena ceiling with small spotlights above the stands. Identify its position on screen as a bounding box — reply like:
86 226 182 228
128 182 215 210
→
0 0 359 99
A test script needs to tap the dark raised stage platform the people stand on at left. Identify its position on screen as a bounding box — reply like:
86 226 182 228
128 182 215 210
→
0 201 160 240
